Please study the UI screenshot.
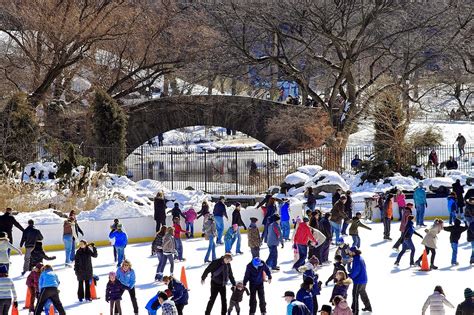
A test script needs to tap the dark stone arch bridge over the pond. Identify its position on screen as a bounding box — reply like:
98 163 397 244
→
126 95 316 154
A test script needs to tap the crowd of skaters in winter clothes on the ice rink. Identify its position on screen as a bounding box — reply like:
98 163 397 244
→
0 180 474 315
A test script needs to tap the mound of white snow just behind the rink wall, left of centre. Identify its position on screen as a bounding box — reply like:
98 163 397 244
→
77 199 153 221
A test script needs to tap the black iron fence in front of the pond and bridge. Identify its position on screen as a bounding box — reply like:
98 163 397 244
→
37 145 474 195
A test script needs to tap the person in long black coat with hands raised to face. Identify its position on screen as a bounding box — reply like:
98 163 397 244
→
74 240 97 302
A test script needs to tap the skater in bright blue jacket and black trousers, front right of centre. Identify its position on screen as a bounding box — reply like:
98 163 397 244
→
349 247 372 315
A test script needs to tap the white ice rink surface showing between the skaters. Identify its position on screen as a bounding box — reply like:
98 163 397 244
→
10 222 474 315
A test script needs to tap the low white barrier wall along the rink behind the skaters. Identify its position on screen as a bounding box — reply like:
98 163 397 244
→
13 198 448 250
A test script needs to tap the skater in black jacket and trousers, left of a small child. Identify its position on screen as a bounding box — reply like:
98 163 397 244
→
201 253 236 315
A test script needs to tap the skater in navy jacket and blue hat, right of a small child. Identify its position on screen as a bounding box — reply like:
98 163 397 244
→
243 257 272 315
